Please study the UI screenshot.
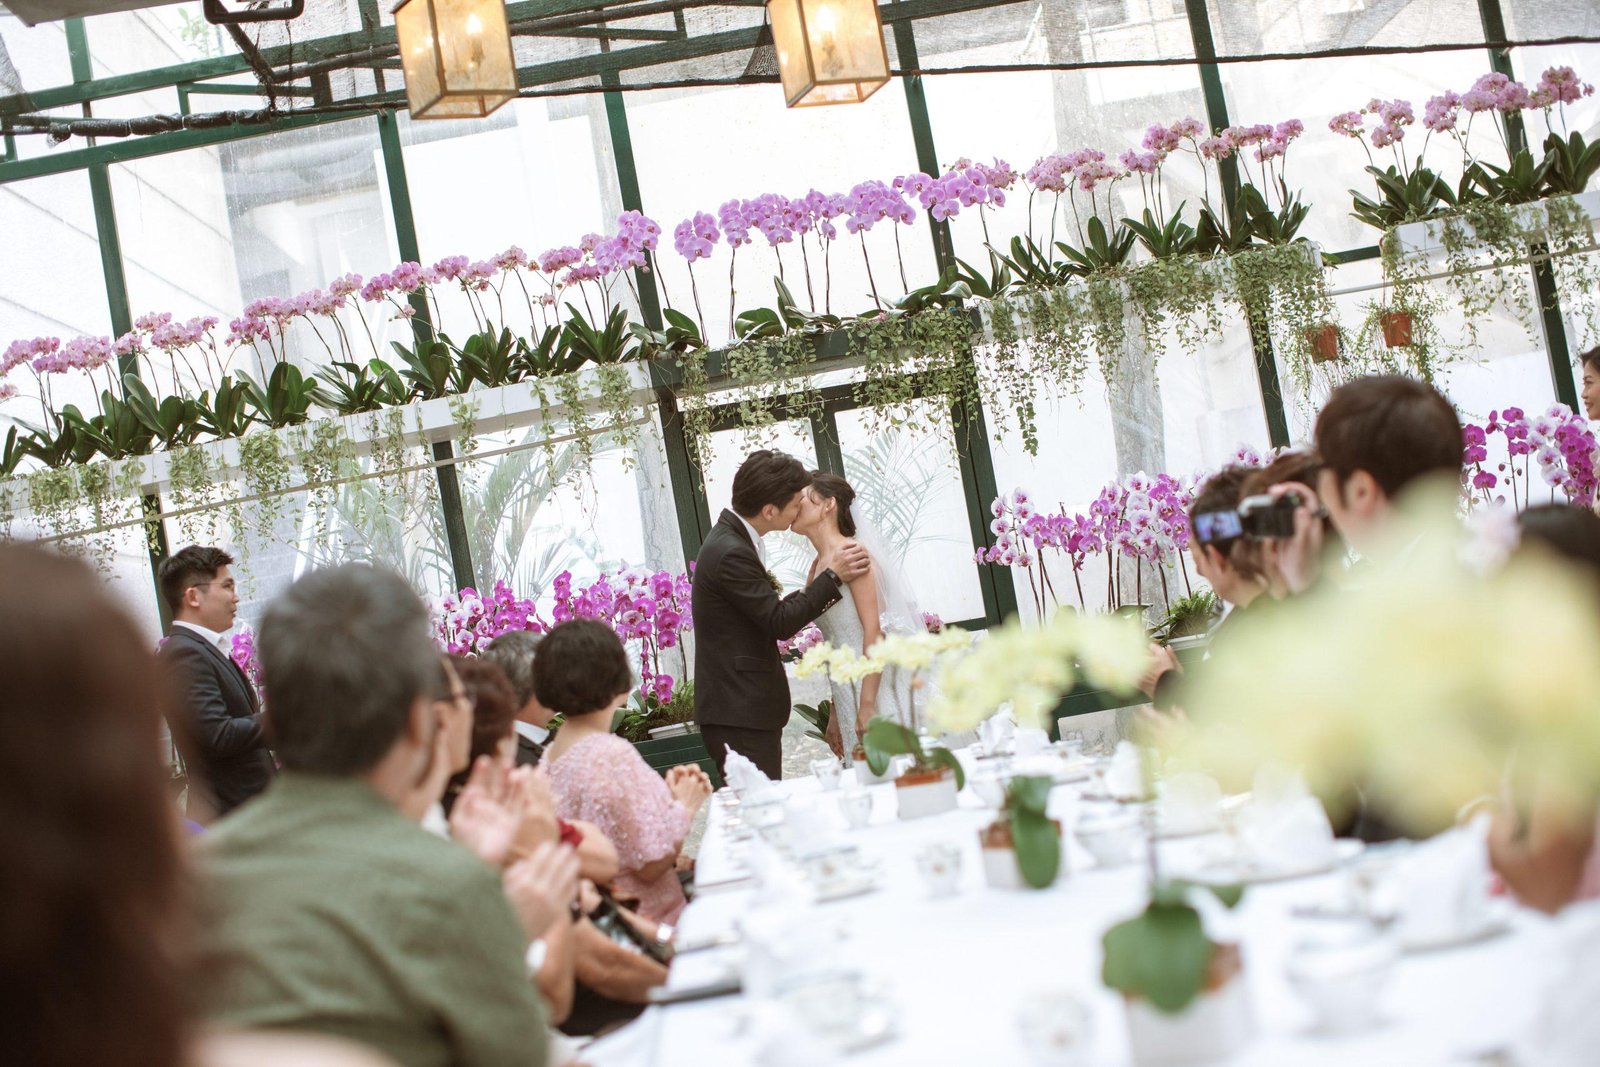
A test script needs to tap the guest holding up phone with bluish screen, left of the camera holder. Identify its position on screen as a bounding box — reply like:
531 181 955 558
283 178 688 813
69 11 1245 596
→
1139 467 1266 712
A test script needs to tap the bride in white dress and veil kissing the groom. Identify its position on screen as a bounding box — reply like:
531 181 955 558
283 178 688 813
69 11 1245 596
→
792 470 926 763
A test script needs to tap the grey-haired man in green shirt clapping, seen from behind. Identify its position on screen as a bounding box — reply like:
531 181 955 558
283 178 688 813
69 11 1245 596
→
196 565 576 1067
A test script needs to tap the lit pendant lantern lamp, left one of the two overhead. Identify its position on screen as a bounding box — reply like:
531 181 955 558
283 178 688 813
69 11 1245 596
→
395 0 517 118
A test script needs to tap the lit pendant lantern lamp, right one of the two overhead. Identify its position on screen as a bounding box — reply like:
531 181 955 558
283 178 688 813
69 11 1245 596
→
766 0 890 107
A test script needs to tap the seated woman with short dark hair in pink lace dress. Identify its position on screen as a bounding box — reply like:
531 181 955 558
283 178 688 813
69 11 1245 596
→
533 619 710 923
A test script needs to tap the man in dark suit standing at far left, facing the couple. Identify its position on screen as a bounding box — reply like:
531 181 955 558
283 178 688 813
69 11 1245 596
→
157 545 275 822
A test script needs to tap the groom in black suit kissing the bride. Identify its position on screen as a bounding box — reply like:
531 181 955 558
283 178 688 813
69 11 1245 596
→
693 450 870 781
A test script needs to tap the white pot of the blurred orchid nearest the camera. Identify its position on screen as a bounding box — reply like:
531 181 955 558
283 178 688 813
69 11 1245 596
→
1126 945 1254 1067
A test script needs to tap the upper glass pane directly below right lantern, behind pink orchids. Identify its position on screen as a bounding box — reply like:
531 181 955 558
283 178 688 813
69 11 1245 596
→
627 83 938 344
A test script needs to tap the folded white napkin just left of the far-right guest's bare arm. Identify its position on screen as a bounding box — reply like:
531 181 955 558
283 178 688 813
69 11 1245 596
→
1384 814 1493 945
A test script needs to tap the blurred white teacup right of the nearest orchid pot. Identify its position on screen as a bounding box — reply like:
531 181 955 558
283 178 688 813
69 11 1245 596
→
1286 923 1398 1033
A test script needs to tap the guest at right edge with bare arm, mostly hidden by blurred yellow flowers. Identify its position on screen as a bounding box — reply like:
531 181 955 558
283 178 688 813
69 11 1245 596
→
1490 504 1600 913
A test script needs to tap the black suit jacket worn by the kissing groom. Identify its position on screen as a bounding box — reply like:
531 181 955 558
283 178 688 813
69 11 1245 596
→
691 512 840 729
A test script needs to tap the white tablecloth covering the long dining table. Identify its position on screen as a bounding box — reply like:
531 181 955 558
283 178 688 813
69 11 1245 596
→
584 758 1561 1067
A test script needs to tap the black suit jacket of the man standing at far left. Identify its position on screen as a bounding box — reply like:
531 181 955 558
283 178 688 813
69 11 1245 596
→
160 625 275 816
